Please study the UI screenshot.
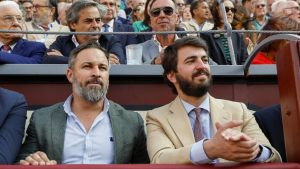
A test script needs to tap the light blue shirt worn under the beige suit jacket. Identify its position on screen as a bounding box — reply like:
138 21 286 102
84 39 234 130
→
180 96 271 164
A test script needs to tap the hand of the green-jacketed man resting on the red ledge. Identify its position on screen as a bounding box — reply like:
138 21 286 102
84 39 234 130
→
20 151 57 165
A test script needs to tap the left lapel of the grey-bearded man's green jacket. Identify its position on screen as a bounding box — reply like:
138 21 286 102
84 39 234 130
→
50 104 67 163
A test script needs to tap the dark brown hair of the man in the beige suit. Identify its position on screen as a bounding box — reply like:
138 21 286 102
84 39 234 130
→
162 36 209 94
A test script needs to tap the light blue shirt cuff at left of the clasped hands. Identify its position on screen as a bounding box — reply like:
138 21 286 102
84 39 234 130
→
190 139 213 164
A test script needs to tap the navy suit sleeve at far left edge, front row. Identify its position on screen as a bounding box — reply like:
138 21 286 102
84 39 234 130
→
0 94 27 164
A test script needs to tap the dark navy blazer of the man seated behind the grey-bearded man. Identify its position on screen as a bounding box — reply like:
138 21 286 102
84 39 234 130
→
43 35 126 64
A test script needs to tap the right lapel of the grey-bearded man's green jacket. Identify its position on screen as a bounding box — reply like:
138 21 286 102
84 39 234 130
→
108 102 123 163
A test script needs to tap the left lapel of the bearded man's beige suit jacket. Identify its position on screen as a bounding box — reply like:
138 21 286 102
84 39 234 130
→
167 97 195 146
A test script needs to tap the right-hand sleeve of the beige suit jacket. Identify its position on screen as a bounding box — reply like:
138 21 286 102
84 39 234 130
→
241 103 282 162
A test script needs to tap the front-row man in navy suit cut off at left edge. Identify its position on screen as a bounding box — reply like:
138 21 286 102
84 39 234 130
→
0 88 27 164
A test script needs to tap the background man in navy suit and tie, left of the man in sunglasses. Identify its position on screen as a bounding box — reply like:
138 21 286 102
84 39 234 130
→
99 0 136 51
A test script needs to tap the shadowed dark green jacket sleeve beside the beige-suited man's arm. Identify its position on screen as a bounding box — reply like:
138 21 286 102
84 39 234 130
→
132 114 150 164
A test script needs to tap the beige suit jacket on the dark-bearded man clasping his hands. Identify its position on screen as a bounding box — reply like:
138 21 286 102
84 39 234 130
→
146 96 281 164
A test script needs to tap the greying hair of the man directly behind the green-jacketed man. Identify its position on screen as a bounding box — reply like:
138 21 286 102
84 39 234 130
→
66 0 106 31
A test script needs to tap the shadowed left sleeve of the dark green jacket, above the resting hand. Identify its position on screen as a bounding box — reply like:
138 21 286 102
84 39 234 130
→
16 112 39 162
